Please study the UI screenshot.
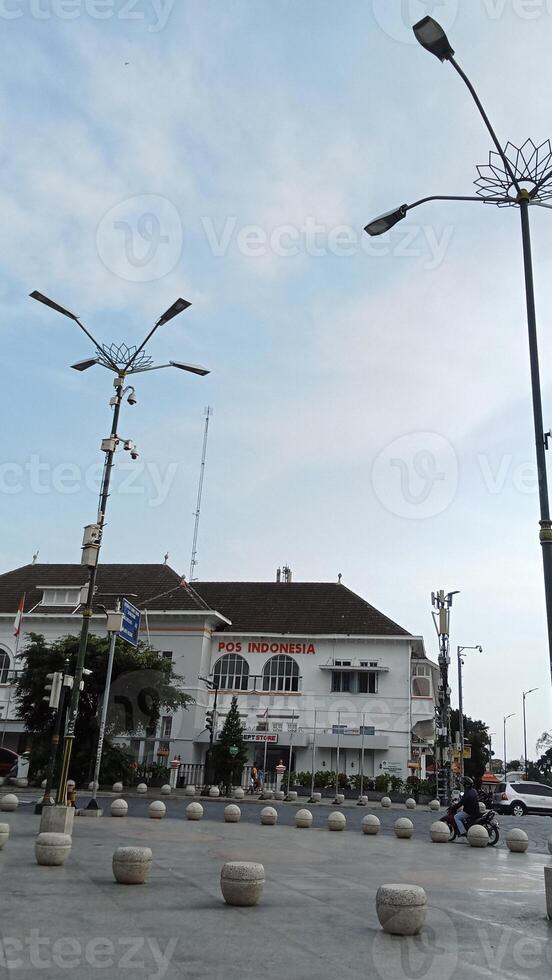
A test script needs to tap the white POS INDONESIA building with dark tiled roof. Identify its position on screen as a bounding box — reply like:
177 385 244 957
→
0 564 438 778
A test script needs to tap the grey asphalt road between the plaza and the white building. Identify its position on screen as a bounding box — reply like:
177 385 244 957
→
11 790 552 854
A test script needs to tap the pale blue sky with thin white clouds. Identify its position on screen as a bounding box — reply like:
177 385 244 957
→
0 0 552 758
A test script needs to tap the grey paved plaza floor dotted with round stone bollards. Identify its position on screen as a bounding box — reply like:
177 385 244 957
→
0 810 552 980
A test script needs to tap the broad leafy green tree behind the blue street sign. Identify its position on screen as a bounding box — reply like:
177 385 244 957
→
16 633 193 783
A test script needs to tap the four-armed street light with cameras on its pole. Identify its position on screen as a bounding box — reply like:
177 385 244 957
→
31 290 209 804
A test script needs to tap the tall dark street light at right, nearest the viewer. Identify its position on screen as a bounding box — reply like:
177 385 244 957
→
365 17 552 688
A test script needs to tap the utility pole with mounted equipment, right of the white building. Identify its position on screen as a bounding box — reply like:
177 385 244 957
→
431 589 458 804
